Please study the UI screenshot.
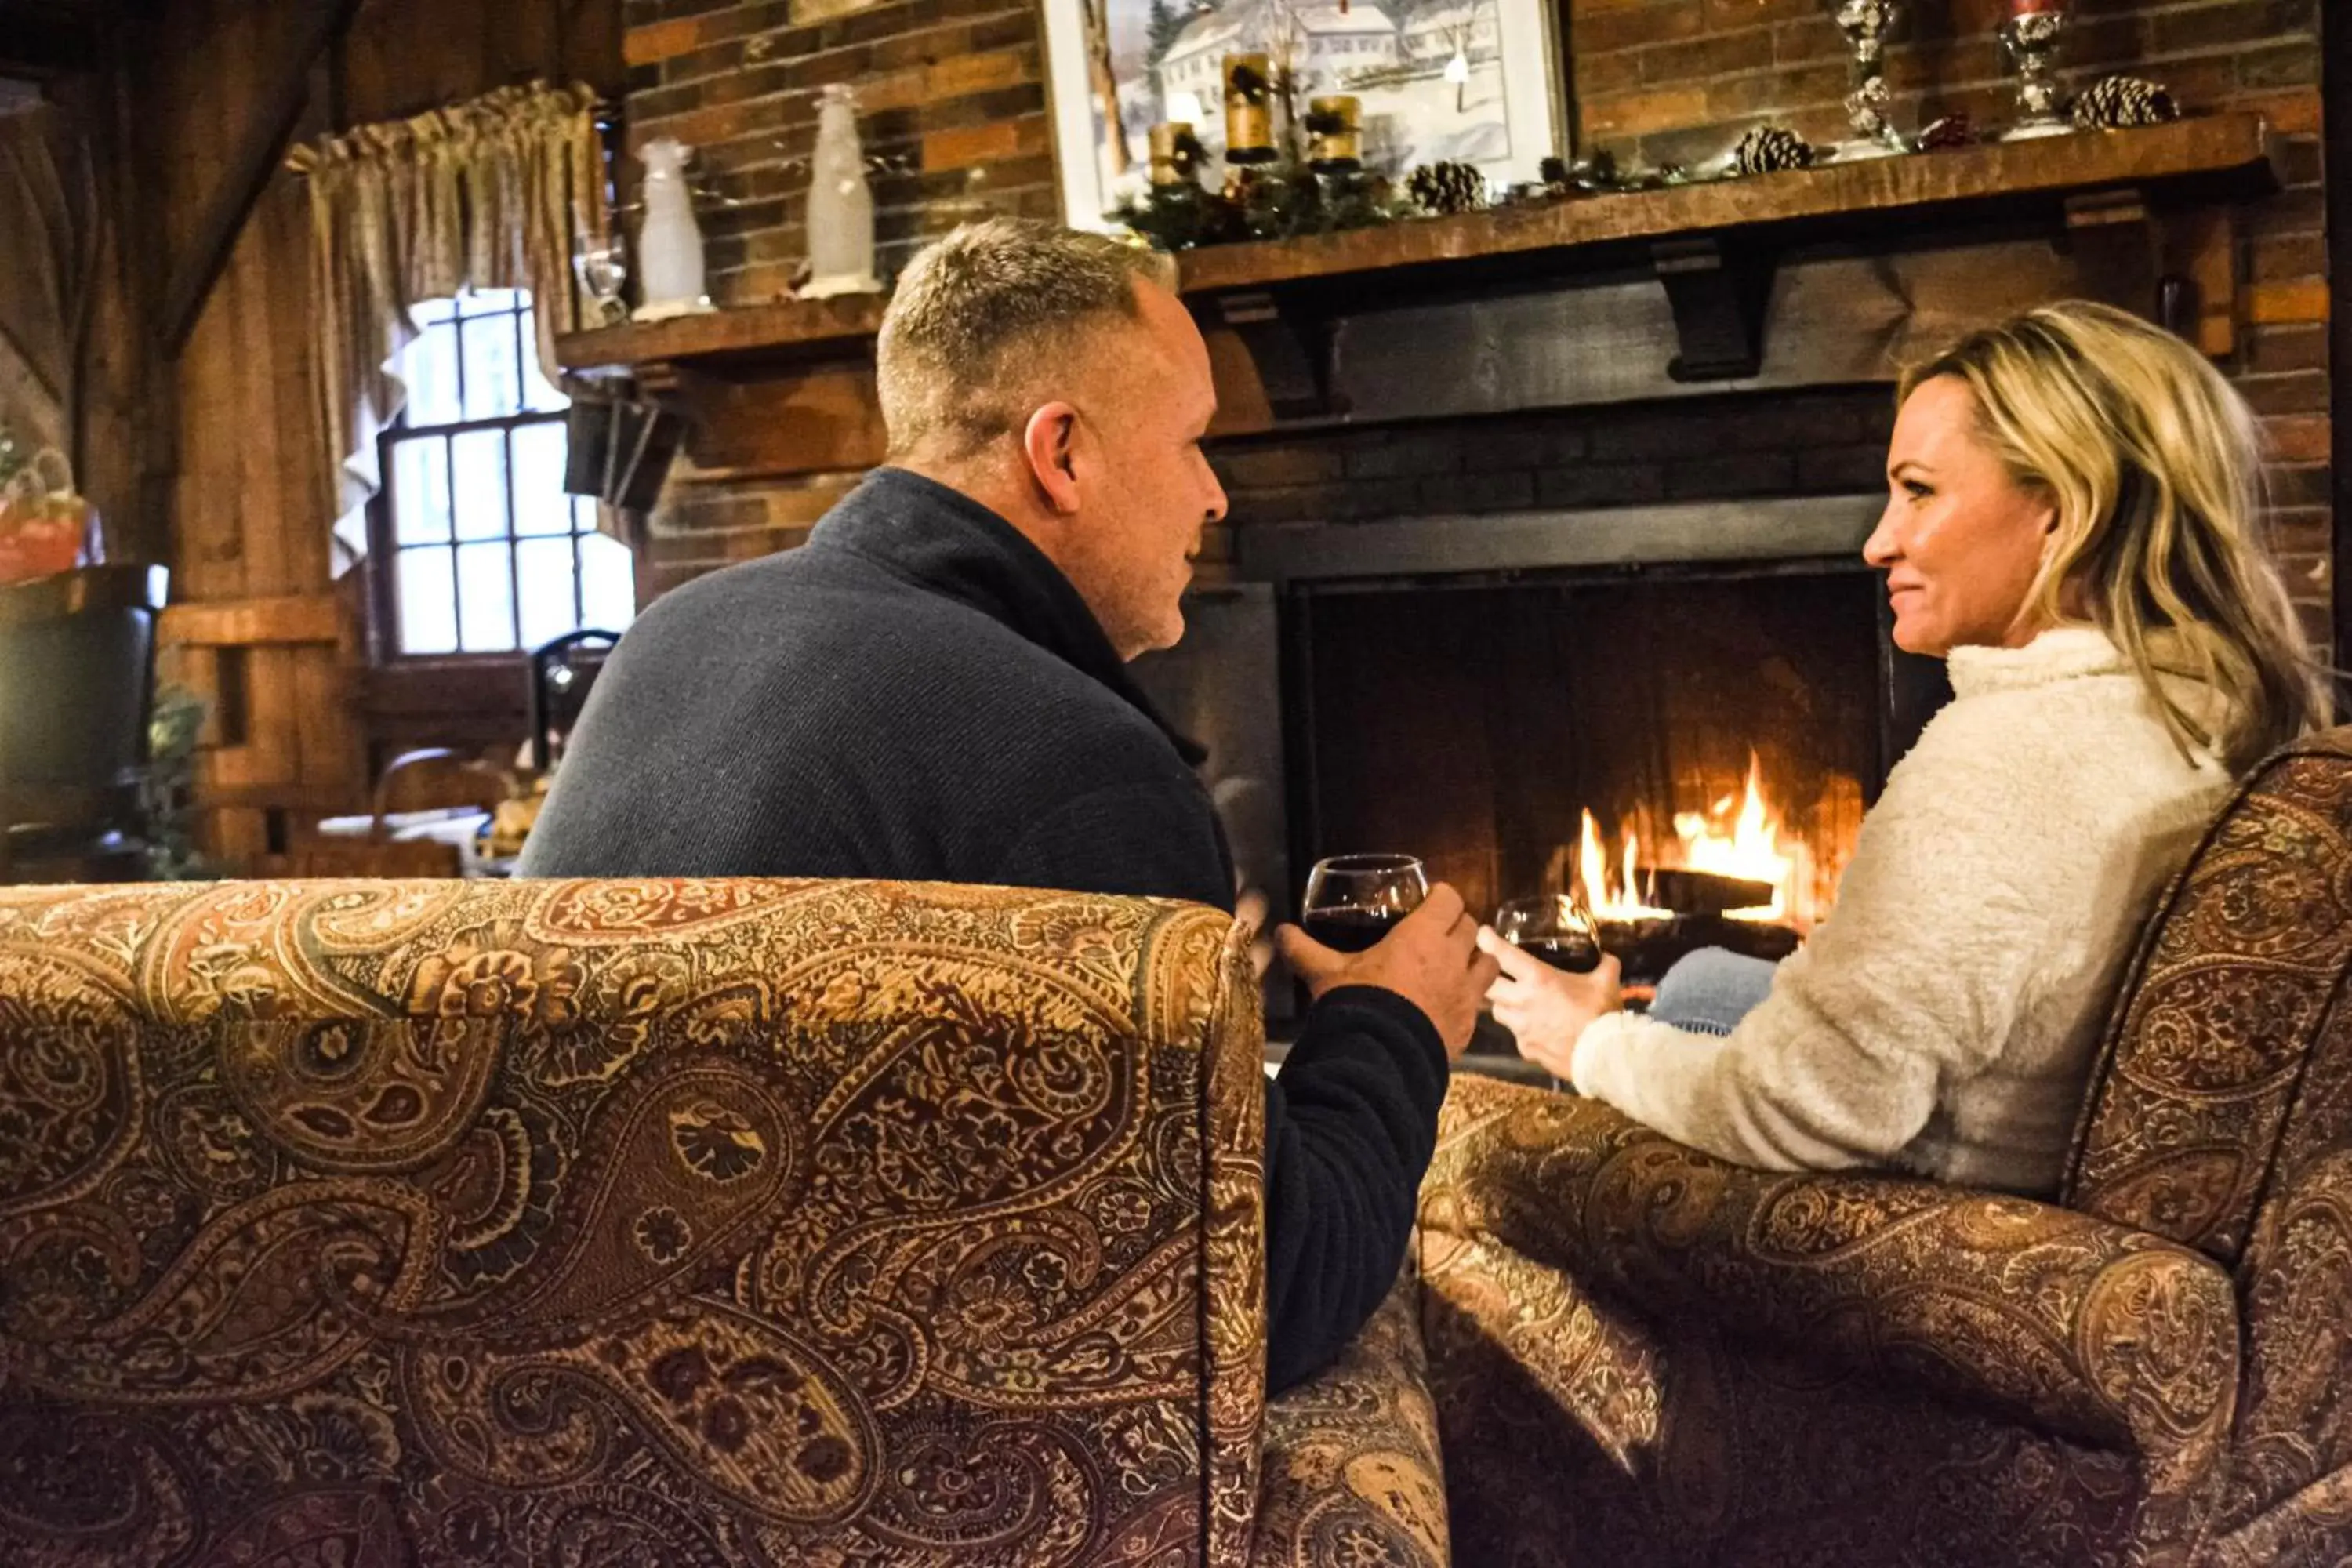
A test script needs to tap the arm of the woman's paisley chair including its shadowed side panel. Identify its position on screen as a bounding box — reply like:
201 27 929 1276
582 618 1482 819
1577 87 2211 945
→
1421 1079 2237 1563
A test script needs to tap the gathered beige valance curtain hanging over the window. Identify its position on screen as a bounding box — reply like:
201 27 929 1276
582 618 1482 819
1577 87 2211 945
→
287 85 612 560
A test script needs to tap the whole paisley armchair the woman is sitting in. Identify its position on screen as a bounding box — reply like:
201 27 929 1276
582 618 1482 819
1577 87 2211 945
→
1421 731 2352 1568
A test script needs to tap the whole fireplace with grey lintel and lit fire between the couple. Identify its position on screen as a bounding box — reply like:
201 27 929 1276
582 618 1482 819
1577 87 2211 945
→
1136 496 1945 1025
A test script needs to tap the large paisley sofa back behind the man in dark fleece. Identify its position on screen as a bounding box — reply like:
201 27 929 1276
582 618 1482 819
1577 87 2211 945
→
0 879 1263 1568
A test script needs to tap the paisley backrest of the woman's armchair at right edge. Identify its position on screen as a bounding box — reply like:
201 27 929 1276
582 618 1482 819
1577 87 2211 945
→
2065 729 2352 1563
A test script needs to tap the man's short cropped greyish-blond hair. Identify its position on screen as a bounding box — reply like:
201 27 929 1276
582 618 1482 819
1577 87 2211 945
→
875 219 1176 461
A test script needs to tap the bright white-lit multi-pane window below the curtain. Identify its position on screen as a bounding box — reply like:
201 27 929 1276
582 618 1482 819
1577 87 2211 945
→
374 289 637 659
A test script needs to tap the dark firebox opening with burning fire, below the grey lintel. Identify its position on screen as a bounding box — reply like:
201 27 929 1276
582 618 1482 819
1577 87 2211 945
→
1282 562 1889 933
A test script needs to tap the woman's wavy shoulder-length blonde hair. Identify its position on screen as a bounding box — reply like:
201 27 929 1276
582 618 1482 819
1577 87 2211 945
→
1900 301 2326 771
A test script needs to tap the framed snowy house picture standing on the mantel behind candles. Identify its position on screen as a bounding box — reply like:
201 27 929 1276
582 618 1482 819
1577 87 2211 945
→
1040 0 1569 228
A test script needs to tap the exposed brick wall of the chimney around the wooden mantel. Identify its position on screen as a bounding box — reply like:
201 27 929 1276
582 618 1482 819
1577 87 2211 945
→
626 0 2333 642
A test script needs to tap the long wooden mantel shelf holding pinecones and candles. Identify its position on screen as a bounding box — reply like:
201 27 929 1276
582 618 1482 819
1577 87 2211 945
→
555 113 2279 381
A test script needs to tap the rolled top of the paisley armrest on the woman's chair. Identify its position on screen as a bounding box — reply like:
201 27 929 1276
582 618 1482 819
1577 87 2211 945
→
1421 1079 2237 1481
